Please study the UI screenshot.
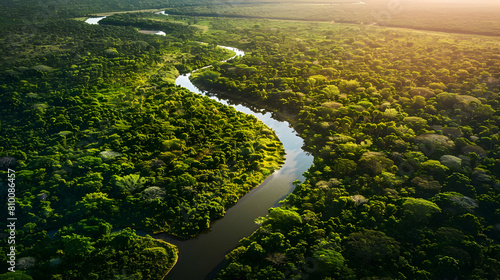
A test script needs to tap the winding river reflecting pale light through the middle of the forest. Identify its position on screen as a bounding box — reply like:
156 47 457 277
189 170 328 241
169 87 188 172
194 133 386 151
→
85 16 313 280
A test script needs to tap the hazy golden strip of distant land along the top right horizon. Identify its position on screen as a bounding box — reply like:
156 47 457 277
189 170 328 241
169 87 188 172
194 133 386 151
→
167 0 500 36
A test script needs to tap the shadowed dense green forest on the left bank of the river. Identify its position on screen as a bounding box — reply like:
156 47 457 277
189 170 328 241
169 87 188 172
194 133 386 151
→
0 11 283 279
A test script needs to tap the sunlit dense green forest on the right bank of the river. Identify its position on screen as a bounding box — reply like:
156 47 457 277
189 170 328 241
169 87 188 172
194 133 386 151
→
185 17 500 279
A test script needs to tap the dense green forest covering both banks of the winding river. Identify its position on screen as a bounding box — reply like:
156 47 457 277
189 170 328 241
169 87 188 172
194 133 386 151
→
0 0 500 280
